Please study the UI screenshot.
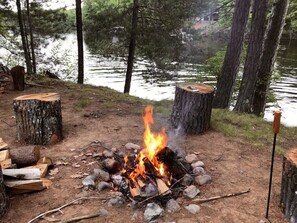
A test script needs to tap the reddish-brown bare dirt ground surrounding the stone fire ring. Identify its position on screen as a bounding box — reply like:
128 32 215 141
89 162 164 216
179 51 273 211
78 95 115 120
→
0 80 288 223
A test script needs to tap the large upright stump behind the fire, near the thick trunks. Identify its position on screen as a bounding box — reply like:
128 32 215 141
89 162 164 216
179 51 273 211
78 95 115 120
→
171 83 214 134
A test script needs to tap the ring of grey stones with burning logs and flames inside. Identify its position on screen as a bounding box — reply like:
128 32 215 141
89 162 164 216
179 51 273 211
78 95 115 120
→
83 106 211 220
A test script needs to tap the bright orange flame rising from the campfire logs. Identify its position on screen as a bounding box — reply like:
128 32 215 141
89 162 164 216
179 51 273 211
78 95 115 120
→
129 106 167 182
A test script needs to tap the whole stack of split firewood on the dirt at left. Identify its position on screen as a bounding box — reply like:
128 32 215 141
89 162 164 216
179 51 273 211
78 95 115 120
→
0 138 53 194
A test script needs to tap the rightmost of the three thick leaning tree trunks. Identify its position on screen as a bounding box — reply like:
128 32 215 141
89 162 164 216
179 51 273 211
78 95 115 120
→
253 0 289 116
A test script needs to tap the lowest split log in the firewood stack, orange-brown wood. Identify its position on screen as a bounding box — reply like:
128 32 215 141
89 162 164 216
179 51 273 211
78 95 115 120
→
4 180 44 194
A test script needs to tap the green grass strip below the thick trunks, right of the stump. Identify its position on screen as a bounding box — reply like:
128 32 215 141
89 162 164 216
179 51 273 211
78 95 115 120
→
211 109 297 153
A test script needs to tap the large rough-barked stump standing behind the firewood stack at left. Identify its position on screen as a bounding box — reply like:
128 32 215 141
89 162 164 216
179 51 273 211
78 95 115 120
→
13 93 63 145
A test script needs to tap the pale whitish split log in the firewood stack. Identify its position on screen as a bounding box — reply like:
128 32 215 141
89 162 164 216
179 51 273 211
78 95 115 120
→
2 168 40 180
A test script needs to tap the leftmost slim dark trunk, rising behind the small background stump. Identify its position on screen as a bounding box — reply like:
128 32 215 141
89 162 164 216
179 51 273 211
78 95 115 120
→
16 0 32 73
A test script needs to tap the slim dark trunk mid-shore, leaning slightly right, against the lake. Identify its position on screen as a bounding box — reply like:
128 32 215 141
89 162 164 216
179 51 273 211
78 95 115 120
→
124 0 139 94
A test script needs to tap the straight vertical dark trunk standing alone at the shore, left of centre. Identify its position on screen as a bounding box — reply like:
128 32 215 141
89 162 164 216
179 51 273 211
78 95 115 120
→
76 0 84 84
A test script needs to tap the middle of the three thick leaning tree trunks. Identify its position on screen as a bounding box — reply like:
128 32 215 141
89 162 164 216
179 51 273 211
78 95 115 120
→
234 0 268 113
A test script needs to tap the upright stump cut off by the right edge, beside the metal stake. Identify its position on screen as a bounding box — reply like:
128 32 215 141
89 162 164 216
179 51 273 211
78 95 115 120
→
281 148 297 223
